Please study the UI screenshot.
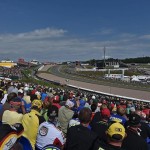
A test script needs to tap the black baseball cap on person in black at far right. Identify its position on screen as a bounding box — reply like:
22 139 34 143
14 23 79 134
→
129 114 141 126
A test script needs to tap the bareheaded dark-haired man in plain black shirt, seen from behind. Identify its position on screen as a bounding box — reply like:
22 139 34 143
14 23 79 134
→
66 107 98 150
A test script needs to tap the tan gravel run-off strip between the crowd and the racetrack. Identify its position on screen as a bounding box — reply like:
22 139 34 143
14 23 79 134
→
38 66 150 101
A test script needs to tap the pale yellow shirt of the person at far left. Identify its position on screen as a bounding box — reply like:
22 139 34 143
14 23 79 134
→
2 110 23 125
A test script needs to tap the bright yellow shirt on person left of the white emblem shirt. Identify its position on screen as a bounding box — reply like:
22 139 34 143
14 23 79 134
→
22 109 40 150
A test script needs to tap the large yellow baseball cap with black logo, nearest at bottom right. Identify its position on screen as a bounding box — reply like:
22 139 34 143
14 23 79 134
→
106 122 126 140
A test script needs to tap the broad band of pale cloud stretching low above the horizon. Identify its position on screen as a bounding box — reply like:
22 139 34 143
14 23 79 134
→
0 28 150 61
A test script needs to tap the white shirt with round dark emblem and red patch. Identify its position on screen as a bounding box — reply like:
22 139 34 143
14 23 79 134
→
36 122 65 148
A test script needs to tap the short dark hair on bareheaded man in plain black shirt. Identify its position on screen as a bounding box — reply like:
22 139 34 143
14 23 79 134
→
79 107 92 123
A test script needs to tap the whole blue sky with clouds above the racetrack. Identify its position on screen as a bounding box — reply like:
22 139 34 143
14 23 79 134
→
0 0 150 62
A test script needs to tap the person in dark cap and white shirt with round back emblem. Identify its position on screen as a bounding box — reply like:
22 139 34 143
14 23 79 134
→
36 106 65 150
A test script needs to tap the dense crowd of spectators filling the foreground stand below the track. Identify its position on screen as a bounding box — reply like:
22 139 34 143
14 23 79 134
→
0 80 150 150
